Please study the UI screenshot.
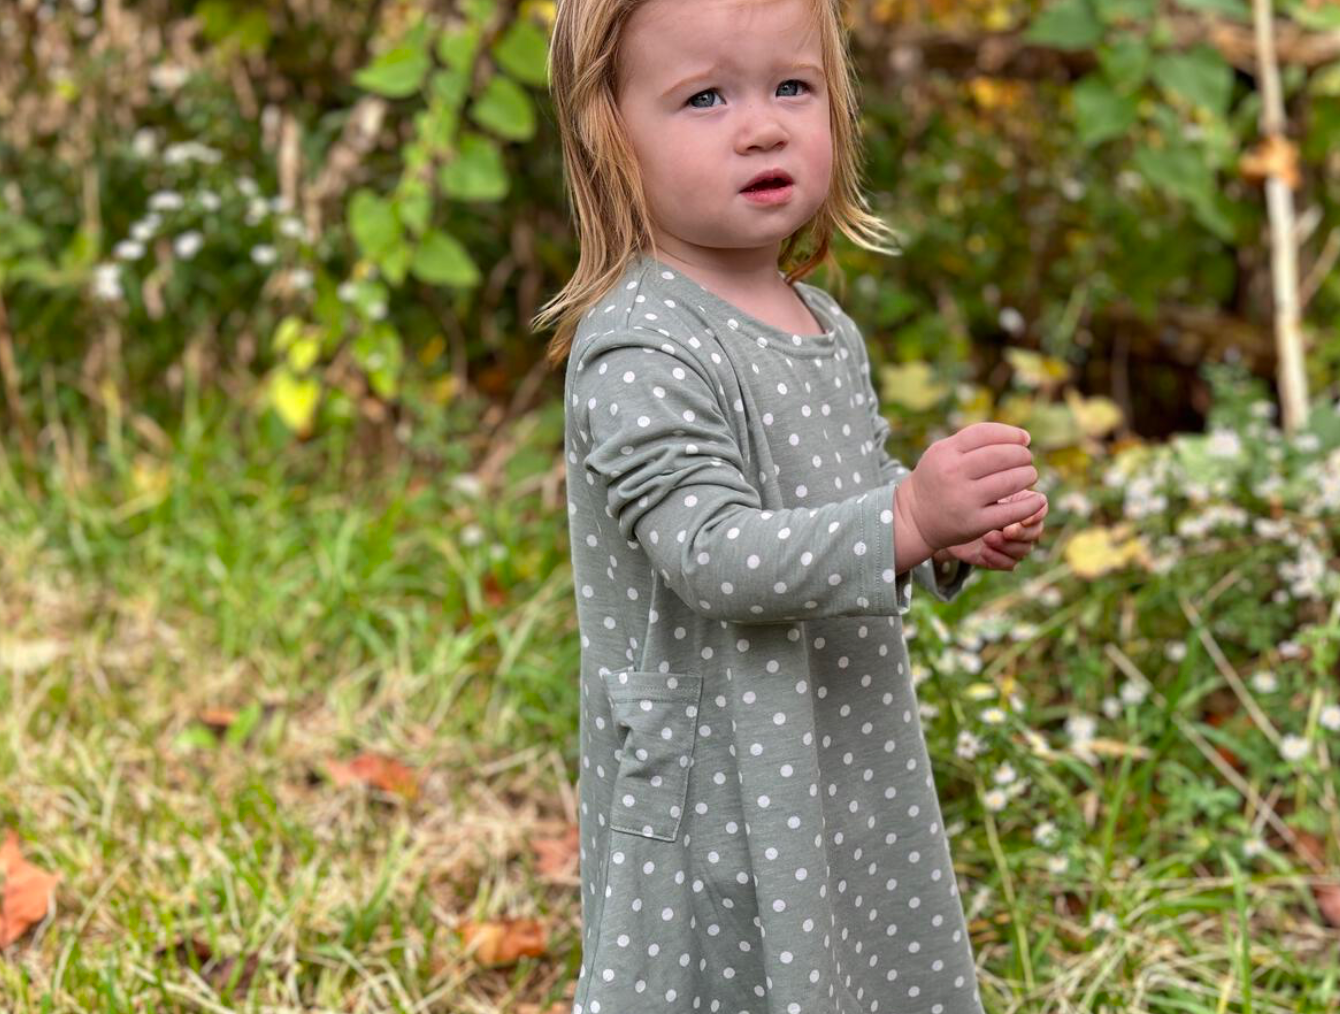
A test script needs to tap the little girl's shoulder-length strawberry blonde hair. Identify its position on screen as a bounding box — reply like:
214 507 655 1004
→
531 0 898 368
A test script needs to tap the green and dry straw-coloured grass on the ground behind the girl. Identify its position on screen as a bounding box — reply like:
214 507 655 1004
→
0 380 1340 1014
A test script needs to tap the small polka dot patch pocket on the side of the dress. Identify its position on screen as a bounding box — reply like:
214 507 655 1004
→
604 671 702 841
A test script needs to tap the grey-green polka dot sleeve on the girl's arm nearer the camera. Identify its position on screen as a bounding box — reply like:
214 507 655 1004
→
570 327 911 623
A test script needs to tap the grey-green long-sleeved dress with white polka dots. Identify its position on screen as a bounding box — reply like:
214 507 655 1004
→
564 255 982 1014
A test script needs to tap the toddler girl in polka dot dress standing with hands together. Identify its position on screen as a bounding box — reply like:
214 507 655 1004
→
536 0 1047 1014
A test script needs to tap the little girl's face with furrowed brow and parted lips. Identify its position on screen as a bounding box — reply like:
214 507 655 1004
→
618 0 832 265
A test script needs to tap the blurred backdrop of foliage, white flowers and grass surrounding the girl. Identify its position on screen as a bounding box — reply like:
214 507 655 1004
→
0 0 1340 1014
